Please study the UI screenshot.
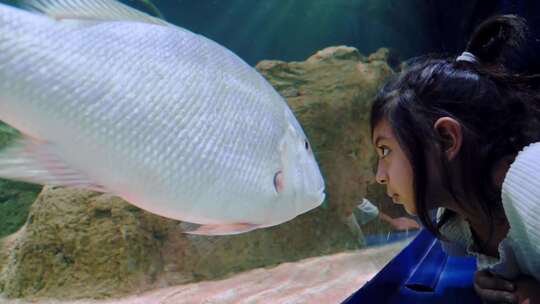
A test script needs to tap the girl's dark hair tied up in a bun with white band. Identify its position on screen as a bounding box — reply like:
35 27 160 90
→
371 15 540 246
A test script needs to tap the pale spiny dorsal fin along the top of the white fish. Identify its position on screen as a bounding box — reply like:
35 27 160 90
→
21 0 170 26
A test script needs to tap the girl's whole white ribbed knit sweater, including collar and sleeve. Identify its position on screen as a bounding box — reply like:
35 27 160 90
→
439 142 540 281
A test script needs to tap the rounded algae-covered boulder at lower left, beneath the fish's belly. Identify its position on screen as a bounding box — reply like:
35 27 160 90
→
0 188 169 297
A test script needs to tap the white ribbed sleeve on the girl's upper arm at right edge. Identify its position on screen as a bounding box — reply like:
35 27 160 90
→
501 143 540 281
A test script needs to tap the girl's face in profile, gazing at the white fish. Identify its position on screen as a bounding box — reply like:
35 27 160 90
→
372 119 417 215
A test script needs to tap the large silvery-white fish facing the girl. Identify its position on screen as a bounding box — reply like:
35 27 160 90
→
0 0 324 235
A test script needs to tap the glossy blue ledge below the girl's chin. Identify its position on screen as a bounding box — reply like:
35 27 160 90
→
343 230 481 304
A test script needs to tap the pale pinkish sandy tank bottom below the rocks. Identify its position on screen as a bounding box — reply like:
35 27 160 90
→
0 241 408 304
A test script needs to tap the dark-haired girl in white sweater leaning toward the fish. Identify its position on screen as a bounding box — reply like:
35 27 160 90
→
371 15 540 303
